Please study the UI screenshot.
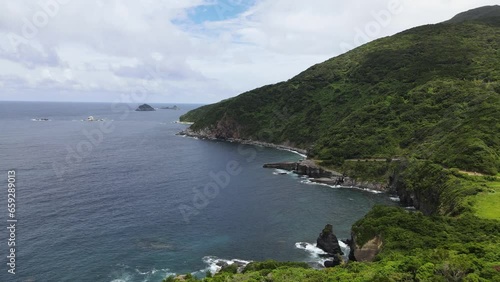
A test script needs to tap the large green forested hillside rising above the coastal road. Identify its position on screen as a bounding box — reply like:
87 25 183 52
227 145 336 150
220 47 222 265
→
181 6 500 175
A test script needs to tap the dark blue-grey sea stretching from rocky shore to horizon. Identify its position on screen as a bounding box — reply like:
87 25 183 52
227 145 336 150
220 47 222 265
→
0 102 394 282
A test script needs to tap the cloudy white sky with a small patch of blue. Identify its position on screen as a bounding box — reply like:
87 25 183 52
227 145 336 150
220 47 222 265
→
0 0 499 103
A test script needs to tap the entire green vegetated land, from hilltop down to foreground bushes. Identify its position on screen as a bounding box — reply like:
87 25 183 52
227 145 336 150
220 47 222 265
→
170 6 500 281
